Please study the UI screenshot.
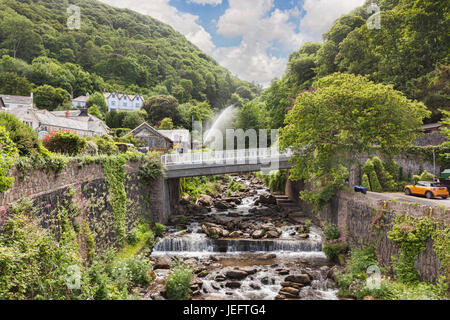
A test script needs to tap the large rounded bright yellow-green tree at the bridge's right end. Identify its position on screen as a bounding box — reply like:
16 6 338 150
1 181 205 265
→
280 73 430 180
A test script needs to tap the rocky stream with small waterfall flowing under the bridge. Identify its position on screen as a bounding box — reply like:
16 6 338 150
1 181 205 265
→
146 176 338 300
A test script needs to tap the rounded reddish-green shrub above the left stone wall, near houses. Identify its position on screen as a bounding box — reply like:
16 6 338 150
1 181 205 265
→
42 130 86 156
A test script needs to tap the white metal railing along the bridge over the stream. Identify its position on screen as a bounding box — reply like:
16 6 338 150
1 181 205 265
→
161 148 291 166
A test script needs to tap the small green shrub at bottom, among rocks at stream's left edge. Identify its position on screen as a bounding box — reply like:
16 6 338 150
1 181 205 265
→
166 264 193 300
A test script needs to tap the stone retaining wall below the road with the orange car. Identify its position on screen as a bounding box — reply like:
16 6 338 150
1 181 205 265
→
286 181 450 282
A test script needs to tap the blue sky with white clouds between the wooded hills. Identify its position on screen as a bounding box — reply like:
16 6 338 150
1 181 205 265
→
101 0 365 87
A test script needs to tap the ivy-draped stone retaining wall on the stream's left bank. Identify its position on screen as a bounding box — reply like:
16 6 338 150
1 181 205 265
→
0 162 170 251
